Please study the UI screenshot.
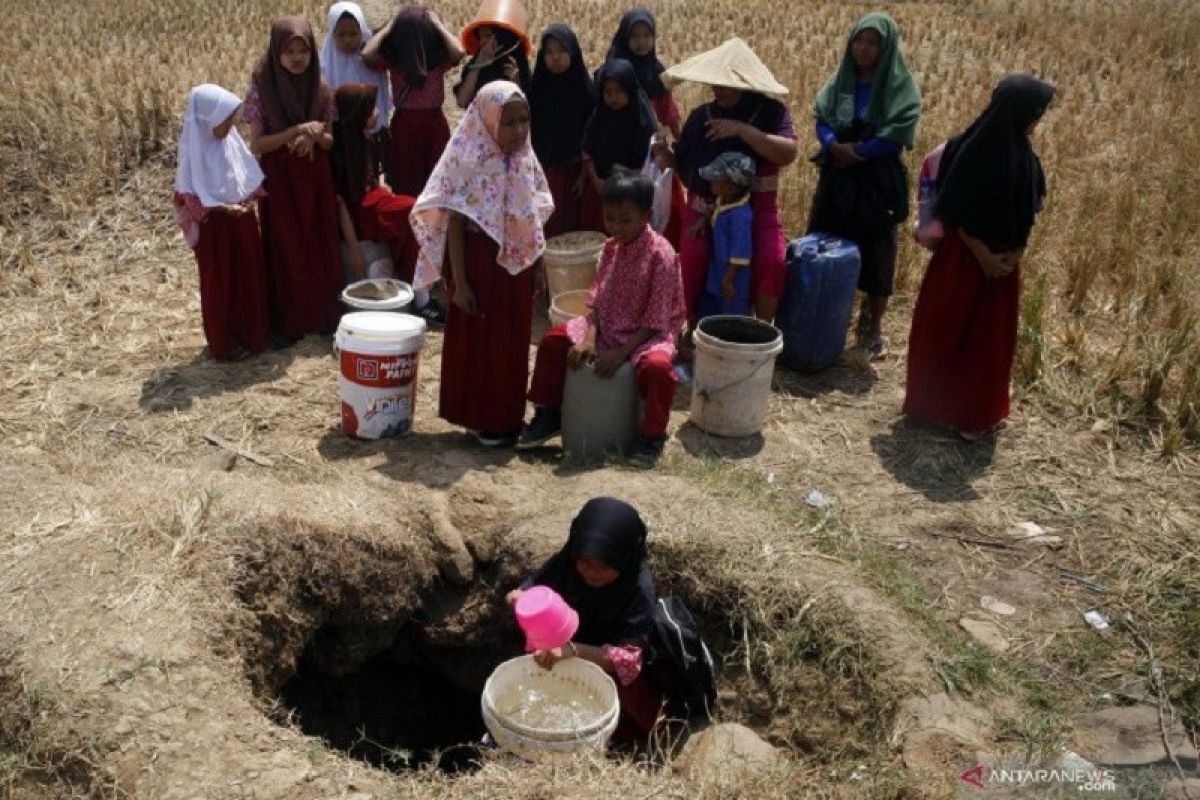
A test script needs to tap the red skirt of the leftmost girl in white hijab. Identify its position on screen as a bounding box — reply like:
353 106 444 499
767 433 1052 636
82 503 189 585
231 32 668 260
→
193 209 269 360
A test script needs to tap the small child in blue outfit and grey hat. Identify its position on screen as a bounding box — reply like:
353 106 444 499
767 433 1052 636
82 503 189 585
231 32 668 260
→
697 151 757 317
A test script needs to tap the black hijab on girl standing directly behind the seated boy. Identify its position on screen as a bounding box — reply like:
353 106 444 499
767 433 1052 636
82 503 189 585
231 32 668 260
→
583 59 659 179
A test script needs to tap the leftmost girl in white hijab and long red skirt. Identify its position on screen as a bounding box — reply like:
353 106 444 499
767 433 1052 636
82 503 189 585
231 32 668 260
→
175 84 268 360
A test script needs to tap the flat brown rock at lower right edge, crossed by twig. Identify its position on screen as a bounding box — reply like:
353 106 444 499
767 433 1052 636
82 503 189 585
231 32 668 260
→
1074 704 1196 767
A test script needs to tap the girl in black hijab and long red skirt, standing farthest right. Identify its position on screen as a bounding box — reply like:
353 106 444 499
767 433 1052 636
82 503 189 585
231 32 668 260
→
904 74 1055 441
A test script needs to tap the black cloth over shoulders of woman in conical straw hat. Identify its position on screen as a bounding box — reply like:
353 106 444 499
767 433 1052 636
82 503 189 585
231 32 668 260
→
676 91 787 199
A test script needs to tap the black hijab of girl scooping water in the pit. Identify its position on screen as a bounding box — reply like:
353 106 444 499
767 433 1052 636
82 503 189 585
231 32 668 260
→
526 498 655 646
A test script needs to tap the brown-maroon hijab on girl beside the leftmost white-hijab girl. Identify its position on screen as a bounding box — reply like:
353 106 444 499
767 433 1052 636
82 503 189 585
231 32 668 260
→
252 17 332 133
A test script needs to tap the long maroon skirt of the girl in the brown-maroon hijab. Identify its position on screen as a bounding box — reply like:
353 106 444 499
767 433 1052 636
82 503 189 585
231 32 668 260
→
258 148 342 338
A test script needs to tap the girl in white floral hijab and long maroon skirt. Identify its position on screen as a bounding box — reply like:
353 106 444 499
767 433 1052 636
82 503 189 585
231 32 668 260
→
412 80 554 447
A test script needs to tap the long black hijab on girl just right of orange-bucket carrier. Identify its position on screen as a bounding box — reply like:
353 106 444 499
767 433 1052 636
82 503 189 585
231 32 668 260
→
529 25 595 164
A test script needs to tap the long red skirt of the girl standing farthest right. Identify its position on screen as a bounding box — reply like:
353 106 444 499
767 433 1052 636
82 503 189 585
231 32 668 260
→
904 229 1021 431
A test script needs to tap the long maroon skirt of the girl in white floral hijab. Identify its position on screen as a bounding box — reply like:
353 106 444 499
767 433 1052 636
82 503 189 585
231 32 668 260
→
438 224 533 433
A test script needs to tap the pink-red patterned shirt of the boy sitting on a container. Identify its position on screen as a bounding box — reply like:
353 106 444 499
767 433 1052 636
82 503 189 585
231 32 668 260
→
566 225 686 363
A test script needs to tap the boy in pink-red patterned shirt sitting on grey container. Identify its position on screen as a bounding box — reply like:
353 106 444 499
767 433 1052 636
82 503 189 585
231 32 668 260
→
517 173 686 467
